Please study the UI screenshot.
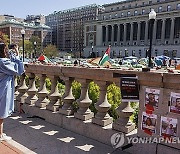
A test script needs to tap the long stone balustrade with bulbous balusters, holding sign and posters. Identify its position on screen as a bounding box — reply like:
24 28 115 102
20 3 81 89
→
15 65 180 153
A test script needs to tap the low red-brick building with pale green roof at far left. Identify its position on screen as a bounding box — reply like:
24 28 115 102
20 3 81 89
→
0 19 52 47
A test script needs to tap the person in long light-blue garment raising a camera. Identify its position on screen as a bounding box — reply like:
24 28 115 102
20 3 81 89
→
0 43 24 142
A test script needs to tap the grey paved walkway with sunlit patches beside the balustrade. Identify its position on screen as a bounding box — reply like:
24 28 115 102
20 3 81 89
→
0 114 127 154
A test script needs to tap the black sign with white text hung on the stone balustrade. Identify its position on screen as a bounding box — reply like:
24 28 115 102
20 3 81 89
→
120 77 139 102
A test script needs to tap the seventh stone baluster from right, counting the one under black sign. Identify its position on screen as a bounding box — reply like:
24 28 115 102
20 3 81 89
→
26 73 38 105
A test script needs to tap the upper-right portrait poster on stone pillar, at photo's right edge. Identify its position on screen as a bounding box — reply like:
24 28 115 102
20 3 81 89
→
169 92 180 114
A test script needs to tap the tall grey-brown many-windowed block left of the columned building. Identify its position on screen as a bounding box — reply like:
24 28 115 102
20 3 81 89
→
46 4 103 54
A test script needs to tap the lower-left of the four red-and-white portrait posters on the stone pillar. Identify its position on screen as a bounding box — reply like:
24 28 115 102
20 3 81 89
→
141 112 157 135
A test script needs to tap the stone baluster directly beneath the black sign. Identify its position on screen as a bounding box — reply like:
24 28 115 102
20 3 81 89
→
113 101 135 133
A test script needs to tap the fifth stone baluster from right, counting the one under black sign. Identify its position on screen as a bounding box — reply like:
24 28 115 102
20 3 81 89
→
46 76 60 112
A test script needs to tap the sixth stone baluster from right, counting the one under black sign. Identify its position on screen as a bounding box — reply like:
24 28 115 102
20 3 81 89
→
35 74 49 108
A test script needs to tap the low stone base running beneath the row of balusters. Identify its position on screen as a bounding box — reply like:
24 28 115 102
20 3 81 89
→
23 104 135 145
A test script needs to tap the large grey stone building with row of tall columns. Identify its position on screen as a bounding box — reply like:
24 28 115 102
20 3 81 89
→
84 0 180 57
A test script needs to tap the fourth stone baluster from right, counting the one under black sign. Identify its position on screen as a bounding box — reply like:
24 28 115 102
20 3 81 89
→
59 77 75 115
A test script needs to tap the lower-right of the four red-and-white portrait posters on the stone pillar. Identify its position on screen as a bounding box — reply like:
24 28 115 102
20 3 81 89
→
160 116 177 138
